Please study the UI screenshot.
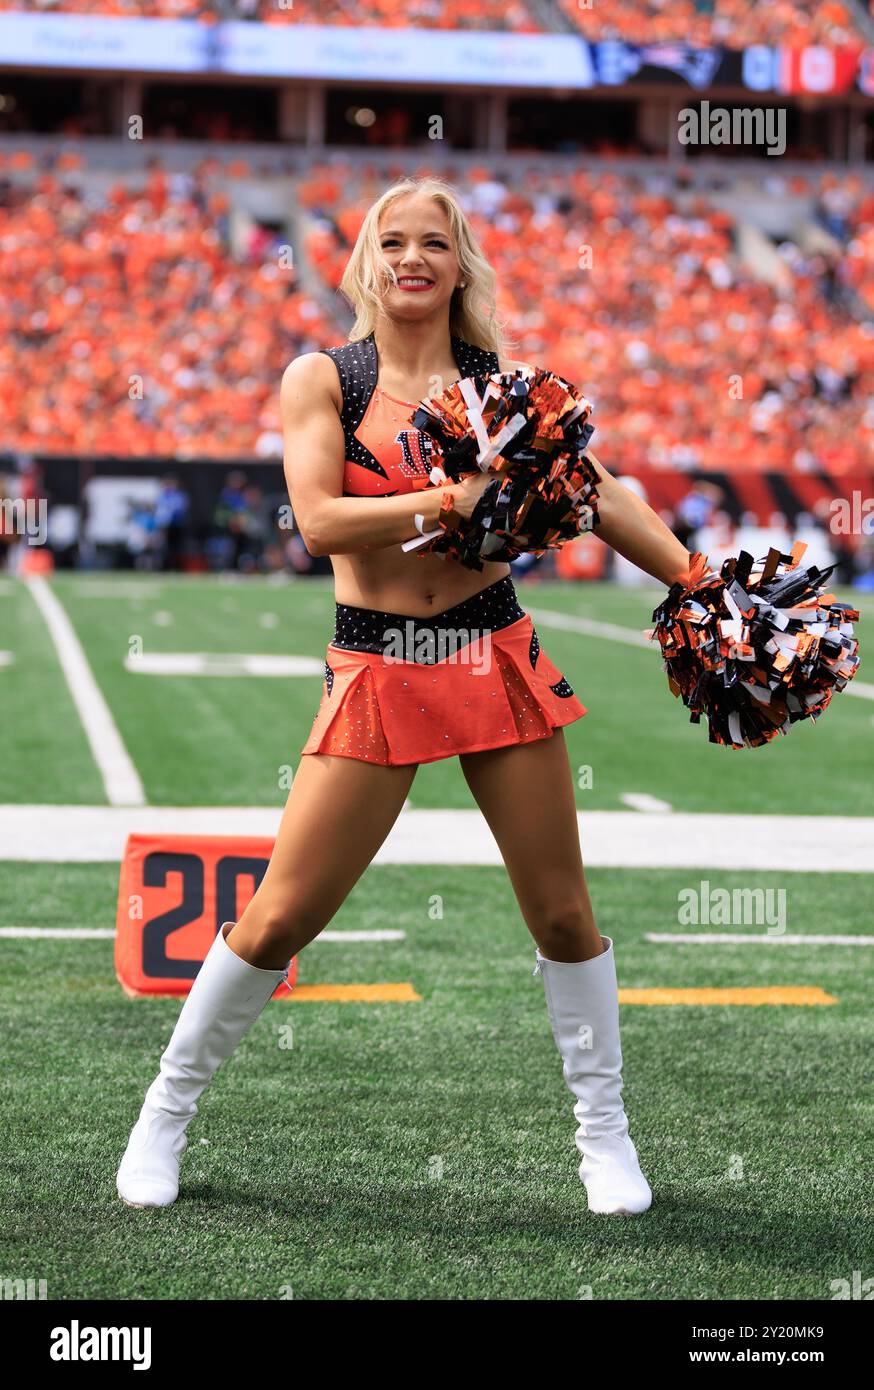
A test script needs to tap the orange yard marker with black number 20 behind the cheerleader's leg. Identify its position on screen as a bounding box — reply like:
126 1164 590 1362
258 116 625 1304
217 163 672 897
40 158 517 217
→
115 834 297 999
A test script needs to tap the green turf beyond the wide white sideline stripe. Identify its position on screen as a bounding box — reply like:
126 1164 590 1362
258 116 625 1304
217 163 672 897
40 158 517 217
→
0 575 874 816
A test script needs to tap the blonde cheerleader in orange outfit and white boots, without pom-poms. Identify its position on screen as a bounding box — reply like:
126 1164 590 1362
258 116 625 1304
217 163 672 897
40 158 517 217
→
117 178 689 1215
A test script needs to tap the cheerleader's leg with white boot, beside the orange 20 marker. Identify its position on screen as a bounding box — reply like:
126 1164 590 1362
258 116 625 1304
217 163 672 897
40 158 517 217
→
117 755 415 1207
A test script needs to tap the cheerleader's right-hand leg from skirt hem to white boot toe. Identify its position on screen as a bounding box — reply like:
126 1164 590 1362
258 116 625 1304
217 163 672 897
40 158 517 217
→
460 728 652 1216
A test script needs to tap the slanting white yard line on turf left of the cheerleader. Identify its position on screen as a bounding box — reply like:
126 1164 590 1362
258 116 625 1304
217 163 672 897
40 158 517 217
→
26 577 146 806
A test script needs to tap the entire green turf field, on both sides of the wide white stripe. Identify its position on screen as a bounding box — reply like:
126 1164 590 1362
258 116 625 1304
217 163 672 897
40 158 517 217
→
0 575 874 1300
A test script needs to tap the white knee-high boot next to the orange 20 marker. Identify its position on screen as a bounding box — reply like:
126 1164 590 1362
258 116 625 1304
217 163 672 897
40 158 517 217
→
117 922 288 1207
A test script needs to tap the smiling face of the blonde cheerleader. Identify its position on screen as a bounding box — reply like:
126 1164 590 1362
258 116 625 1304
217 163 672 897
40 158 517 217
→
379 193 464 318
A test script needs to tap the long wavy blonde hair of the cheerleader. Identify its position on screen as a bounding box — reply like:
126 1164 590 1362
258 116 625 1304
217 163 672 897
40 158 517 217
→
332 175 511 353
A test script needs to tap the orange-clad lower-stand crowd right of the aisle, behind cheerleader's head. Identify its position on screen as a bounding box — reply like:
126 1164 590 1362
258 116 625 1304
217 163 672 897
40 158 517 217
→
300 163 874 470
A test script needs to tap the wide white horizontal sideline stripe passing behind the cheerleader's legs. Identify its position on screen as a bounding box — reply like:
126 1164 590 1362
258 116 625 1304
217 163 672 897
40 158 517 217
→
0 803 874 873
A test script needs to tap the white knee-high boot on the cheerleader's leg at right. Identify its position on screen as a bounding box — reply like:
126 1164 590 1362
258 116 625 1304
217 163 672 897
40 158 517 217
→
534 937 653 1216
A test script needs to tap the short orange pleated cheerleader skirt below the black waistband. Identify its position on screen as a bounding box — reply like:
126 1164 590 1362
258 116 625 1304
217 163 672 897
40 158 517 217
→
302 614 586 767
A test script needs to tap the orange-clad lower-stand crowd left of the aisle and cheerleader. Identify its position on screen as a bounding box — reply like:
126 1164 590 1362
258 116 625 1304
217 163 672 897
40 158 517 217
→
0 168 338 459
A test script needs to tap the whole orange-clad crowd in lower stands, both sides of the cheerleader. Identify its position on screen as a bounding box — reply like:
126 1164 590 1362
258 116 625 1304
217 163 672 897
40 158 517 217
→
0 156 874 473
